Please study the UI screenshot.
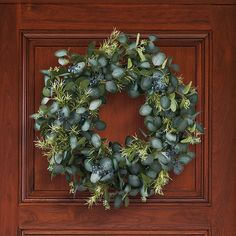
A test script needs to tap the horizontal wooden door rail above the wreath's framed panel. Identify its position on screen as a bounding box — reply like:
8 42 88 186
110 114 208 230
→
19 2 210 32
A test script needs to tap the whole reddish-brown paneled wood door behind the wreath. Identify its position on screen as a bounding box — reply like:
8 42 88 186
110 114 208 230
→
0 0 236 236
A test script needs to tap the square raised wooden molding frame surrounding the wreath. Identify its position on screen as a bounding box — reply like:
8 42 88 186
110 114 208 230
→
20 30 212 205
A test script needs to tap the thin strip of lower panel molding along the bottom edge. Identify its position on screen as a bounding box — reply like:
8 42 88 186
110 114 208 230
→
20 229 210 236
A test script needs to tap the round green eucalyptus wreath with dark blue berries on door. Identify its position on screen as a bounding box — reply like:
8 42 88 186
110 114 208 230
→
32 30 204 209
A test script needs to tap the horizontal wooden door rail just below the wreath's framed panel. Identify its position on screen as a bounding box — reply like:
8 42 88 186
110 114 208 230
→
19 203 210 230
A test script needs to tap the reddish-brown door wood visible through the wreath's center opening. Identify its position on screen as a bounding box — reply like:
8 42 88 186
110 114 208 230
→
99 92 145 144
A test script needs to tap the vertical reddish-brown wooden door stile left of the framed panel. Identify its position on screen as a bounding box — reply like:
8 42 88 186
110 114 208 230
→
0 5 19 236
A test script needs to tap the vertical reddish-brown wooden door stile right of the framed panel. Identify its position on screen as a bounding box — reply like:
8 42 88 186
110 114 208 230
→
211 6 236 236
